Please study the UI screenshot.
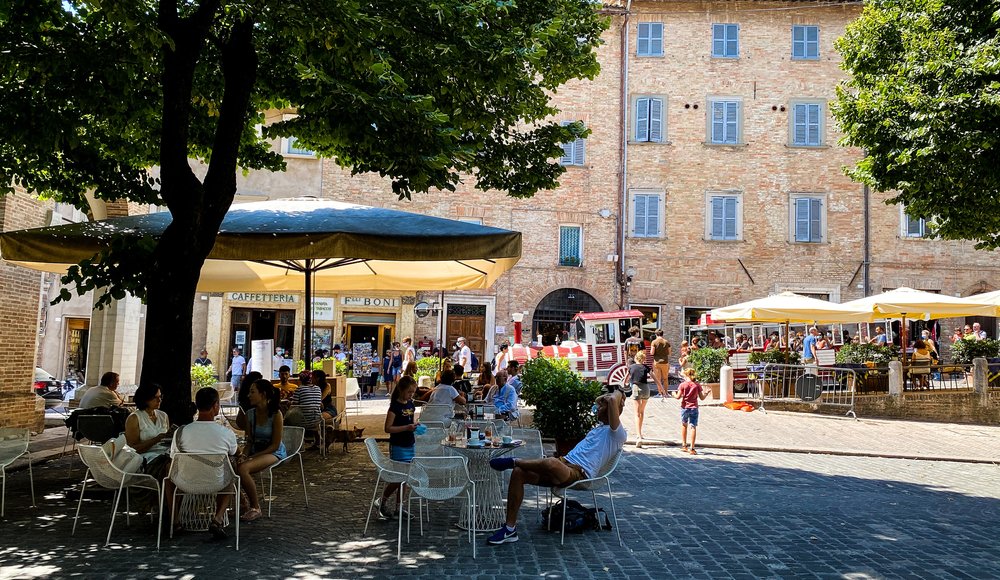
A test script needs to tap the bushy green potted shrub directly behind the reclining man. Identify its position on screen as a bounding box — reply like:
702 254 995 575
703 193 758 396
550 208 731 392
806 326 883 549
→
521 358 604 455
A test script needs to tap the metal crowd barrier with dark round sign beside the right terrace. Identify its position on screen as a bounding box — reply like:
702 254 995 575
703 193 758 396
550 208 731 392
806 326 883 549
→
746 363 867 419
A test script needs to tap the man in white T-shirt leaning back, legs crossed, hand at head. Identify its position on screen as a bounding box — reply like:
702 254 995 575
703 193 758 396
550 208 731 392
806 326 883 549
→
486 391 628 546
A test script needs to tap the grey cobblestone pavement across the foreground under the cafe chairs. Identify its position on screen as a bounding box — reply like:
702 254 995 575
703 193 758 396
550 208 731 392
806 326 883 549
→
0 438 1000 580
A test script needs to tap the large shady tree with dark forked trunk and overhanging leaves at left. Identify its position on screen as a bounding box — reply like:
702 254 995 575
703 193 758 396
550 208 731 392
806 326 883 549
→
0 0 608 416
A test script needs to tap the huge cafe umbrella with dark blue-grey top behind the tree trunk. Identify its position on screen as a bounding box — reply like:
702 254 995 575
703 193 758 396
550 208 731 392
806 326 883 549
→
0 197 521 356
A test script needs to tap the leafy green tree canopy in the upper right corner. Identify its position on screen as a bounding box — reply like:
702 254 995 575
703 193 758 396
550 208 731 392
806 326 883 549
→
833 0 1000 249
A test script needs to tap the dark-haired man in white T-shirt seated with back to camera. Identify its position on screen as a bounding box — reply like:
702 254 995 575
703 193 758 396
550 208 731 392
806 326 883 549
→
163 387 236 539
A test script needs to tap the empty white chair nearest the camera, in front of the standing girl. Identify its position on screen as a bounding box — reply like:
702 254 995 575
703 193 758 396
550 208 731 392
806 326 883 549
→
396 456 476 559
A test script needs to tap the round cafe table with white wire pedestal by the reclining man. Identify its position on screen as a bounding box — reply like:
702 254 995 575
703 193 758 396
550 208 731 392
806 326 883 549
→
442 440 523 532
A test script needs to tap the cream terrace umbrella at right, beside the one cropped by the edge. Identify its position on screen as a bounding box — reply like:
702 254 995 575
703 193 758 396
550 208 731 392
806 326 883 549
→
843 287 996 376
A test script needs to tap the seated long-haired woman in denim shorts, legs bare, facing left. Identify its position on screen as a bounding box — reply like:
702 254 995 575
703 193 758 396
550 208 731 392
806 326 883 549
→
236 379 288 522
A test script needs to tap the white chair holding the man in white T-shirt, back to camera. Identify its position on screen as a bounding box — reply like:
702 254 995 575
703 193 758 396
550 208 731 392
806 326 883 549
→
163 453 240 550
